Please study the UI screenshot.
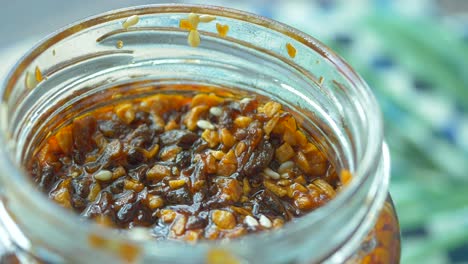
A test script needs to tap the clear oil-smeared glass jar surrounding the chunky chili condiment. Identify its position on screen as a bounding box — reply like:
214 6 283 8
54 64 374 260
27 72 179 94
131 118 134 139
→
0 5 400 263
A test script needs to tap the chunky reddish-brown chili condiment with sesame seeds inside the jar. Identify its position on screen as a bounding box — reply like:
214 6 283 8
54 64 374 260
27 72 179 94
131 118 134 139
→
29 86 342 241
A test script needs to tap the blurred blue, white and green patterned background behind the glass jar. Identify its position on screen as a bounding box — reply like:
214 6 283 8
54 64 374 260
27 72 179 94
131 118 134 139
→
0 0 468 264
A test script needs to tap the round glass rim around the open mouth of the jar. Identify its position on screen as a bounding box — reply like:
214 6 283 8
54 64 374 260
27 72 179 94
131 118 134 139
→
0 4 388 262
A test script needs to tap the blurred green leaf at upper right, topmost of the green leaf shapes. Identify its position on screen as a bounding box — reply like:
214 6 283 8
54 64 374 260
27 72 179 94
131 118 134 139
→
364 14 468 109
